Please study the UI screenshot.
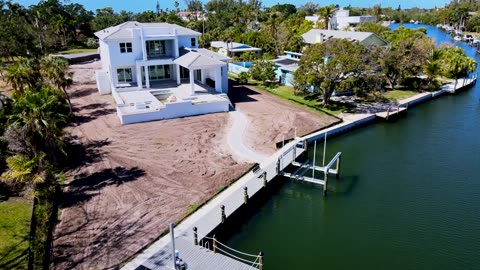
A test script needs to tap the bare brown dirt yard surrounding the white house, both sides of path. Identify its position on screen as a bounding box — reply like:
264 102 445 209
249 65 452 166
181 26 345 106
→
53 62 333 269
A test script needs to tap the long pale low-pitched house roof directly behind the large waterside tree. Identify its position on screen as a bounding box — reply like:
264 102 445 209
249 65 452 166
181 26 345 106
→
302 29 388 46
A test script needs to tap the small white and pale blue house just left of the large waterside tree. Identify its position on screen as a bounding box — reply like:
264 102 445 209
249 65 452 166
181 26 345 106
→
273 51 302 87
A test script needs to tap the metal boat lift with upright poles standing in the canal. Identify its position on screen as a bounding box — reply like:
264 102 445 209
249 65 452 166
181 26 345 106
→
279 133 342 196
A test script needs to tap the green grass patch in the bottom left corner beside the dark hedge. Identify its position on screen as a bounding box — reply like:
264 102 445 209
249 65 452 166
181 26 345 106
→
0 198 32 269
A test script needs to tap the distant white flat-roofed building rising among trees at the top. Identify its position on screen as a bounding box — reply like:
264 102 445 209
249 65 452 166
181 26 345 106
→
305 9 377 30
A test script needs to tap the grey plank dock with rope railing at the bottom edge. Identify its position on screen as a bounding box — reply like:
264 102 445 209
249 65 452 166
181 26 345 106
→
142 237 257 270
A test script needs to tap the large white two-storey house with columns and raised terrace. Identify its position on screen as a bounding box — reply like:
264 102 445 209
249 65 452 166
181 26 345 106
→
95 21 230 124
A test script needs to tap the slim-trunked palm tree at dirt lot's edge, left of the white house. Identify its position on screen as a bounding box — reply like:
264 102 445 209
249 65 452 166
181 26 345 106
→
40 56 73 114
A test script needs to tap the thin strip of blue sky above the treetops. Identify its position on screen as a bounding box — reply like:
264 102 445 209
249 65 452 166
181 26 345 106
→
13 0 450 12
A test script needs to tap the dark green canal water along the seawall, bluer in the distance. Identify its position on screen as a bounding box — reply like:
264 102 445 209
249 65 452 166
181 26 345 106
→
223 25 480 270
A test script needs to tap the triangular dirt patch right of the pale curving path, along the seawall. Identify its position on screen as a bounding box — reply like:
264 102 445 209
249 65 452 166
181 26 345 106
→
229 86 338 154
